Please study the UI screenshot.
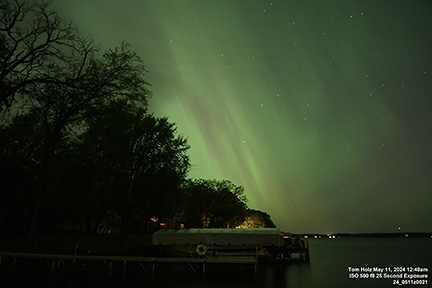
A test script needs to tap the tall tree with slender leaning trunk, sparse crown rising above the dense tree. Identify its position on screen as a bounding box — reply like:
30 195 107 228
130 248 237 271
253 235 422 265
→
22 43 150 240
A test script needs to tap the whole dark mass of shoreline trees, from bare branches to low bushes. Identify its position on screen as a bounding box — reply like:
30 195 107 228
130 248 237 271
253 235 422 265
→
0 0 274 241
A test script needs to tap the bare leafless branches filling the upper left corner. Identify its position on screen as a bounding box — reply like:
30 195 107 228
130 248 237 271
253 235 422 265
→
0 0 95 104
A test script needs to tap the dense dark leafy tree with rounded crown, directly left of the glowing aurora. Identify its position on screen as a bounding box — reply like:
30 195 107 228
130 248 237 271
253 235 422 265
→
84 101 189 235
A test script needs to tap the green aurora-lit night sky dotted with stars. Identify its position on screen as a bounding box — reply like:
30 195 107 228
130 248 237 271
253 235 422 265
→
53 0 432 233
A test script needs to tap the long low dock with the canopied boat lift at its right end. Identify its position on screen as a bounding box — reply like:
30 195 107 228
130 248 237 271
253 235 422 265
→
0 228 310 276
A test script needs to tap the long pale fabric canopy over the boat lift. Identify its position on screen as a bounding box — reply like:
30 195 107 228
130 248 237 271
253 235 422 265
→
152 228 284 247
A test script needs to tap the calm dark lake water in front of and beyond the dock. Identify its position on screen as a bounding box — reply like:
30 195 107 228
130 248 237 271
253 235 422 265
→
1 238 432 288
